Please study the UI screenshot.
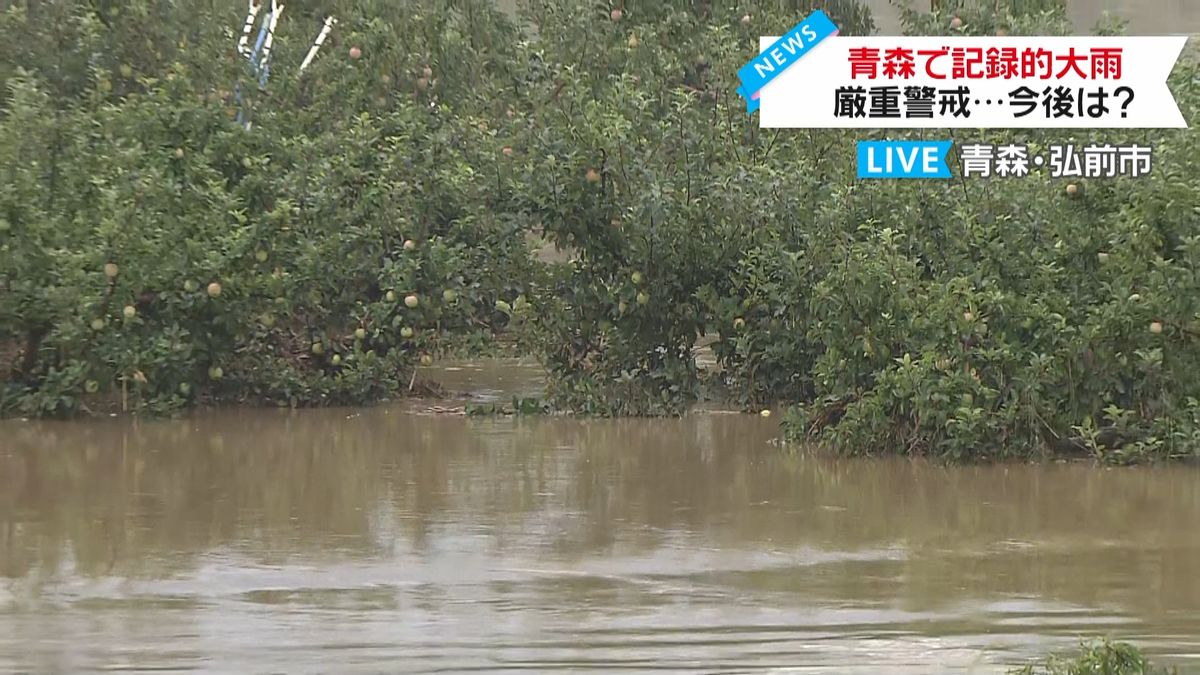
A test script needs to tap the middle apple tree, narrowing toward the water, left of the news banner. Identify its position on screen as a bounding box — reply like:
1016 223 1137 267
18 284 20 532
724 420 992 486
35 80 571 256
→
514 1 871 414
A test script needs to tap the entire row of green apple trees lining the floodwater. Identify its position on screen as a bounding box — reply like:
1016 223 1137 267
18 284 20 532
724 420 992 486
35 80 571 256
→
0 0 1200 461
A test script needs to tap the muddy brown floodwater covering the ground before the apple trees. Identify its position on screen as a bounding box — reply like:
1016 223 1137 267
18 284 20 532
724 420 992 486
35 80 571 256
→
0 360 1200 674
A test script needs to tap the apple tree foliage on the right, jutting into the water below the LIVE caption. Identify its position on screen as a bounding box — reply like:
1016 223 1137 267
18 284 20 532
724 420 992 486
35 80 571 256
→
781 5 1200 461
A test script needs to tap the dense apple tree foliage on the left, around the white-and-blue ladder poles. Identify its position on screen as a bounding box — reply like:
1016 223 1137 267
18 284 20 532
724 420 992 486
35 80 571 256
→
0 0 536 414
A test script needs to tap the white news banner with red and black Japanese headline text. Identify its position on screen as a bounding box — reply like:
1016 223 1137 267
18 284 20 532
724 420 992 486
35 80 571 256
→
758 36 1187 129
